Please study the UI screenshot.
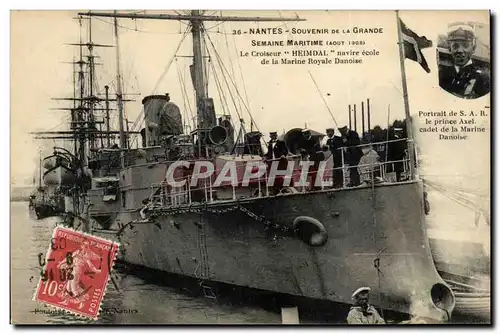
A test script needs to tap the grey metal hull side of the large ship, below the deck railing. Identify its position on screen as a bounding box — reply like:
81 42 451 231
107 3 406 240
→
91 181 454 321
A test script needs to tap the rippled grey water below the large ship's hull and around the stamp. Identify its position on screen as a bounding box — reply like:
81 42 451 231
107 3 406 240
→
11 202 281 324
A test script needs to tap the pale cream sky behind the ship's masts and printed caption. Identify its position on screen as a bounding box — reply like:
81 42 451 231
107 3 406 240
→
11 11 490 197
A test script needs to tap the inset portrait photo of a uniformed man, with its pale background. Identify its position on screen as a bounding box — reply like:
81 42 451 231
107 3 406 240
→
437 22 490 99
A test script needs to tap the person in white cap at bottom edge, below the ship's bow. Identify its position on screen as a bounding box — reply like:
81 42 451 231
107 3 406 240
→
347 287 385 325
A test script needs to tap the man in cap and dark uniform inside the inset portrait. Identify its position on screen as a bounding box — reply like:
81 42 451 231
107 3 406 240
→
439 25 490 99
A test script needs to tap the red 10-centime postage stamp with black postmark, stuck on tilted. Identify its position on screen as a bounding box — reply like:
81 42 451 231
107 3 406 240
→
33 227 119 319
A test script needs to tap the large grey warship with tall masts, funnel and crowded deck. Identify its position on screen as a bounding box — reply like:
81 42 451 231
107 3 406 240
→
31 10 455 321
